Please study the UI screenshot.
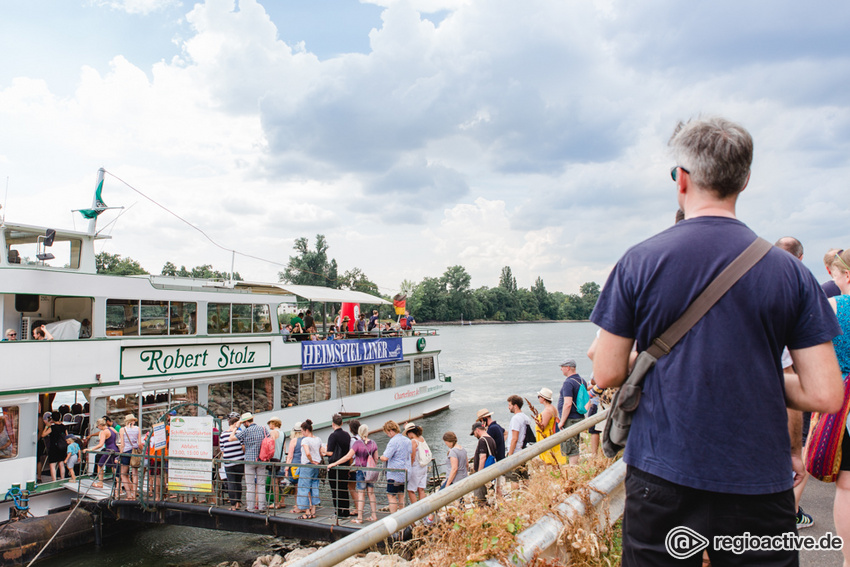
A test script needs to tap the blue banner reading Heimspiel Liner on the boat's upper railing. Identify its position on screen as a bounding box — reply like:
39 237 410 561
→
301 337 404 370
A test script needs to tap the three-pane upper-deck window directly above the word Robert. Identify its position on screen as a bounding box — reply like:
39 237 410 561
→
106 299 198 337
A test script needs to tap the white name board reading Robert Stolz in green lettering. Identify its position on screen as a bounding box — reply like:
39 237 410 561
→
121 343 271 378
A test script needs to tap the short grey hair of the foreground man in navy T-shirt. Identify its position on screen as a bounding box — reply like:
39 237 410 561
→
668 117 753 199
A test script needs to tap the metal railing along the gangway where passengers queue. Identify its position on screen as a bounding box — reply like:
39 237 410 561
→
82 451 420 517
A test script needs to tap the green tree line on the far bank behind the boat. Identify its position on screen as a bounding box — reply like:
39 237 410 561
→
97 234 600 323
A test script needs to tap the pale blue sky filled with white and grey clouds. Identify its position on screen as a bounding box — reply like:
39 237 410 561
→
0 0 850 294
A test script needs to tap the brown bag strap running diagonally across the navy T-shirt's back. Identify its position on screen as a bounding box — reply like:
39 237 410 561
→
646 238 773 359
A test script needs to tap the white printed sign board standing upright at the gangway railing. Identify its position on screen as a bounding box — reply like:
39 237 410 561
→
168 415 213 494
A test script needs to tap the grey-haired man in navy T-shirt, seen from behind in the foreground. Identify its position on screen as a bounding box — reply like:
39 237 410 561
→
591 118 843 567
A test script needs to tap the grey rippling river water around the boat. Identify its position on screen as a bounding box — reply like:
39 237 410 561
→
39 323 596 567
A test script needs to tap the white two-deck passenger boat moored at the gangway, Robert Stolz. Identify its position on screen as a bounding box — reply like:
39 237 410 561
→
0 170 452 521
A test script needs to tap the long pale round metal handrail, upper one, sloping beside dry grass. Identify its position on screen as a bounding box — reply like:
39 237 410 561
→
292 409 609 567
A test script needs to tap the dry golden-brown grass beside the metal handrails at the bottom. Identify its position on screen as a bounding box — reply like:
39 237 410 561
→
397 446 619 567
